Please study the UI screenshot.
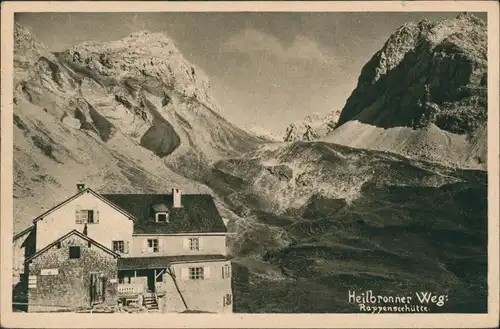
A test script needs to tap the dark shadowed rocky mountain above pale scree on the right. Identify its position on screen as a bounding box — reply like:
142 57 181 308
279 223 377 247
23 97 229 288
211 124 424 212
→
337 14 487 134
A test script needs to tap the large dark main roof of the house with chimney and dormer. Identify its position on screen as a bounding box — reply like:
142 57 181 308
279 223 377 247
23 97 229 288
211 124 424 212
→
102 194 227 235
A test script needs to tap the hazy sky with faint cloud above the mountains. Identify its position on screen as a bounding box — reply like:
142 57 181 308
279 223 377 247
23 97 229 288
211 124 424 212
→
16 13 484 135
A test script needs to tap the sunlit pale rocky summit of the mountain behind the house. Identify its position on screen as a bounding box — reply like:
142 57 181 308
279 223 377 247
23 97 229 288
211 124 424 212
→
57 31 216 109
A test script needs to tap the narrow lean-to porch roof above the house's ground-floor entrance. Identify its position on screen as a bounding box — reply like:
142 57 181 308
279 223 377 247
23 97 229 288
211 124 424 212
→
118 255 231 270
